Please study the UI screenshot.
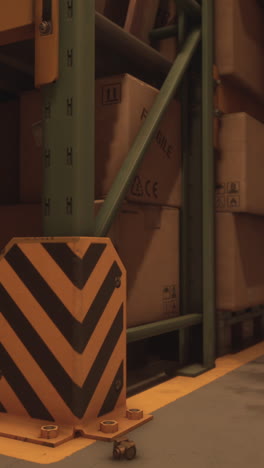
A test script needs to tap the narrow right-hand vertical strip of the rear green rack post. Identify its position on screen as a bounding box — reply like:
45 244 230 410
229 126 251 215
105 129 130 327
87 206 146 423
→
202 0 216 368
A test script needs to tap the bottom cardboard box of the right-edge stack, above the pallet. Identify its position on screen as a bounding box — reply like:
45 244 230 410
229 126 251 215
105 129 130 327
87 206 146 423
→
216 213 264 310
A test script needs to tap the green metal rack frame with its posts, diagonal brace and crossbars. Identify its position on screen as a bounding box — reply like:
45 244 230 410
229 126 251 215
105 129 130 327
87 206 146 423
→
0 0 215 376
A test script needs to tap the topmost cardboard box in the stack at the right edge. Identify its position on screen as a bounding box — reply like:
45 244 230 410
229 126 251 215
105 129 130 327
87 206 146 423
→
215 0 264 101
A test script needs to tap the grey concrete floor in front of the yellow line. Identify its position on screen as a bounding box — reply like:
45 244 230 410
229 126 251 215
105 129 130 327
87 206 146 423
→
0 355 264 468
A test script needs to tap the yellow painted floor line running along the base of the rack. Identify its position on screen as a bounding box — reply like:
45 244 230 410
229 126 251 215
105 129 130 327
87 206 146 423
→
0 342 264 464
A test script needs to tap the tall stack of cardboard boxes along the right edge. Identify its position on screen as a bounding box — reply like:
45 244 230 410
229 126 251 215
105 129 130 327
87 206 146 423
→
215 0 264 330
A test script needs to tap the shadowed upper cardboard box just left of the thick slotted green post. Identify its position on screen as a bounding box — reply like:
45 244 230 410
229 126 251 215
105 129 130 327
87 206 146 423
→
20 90 42 203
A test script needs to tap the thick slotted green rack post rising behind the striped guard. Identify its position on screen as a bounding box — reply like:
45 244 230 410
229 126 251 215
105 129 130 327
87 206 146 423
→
43 0 95 236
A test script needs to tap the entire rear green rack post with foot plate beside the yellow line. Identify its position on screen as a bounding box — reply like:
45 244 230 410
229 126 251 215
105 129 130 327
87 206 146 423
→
178 0 215 376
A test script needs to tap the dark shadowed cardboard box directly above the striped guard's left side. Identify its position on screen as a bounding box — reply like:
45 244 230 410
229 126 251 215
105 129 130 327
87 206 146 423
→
0 204 43 250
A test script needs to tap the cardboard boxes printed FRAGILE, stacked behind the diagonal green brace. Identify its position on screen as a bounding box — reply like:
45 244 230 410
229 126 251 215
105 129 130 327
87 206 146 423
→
95 75 181 327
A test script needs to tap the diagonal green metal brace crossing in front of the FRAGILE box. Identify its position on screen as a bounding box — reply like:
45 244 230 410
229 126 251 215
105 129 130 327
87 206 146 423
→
95 29 201 236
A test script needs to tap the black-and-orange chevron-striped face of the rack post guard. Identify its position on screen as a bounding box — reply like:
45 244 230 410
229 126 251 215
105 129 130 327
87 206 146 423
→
0 237 126 424
